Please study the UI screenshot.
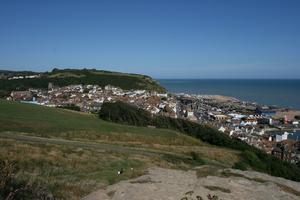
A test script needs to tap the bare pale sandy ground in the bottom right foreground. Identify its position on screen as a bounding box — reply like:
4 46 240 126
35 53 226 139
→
83 166 300 200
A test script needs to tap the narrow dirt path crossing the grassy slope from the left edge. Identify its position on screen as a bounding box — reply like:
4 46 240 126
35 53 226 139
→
0 132 162 156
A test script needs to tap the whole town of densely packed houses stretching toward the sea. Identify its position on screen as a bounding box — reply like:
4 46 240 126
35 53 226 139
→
7 82 300 164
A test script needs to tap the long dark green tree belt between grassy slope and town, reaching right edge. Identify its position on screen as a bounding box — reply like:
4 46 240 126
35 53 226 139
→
99 102 300 181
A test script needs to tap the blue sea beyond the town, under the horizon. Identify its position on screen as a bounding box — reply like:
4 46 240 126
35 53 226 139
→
158 79 300 110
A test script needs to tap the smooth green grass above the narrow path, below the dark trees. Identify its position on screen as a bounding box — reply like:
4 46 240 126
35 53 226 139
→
0 100 201 145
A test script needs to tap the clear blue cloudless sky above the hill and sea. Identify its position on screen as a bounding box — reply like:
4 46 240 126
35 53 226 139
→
0 0 300 78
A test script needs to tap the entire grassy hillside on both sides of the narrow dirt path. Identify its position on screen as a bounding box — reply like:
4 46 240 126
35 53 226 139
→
0 100 238 199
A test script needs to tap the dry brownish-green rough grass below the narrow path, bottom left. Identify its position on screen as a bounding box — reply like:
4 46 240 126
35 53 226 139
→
0 139 146 199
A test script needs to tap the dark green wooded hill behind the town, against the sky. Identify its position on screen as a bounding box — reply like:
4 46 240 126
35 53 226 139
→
0 69 166 96
